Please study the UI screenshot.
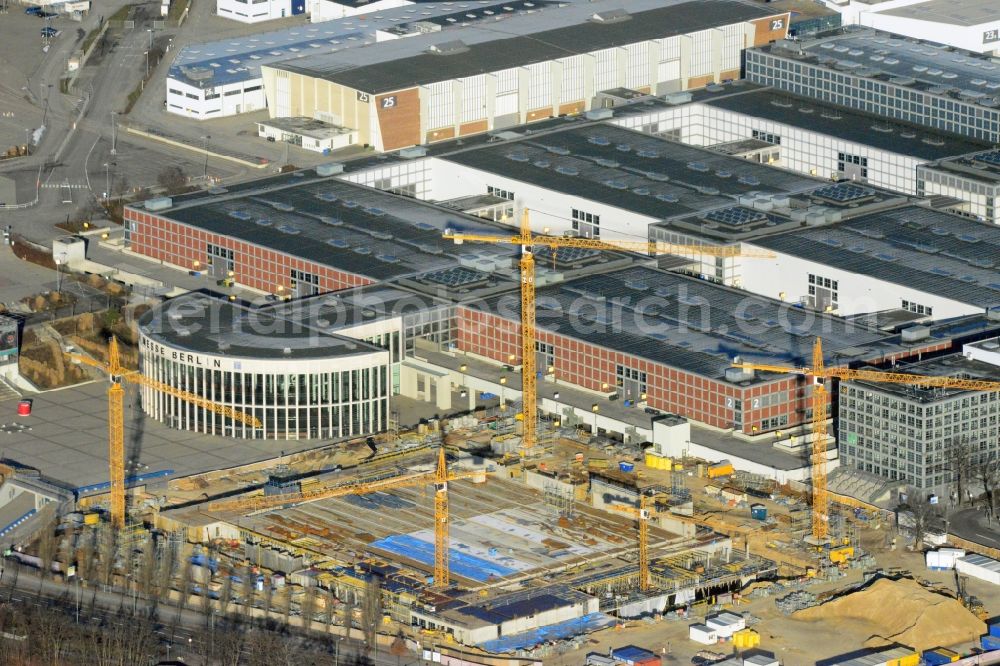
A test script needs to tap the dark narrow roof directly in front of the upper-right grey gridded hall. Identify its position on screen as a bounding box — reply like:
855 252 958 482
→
698 84 990 160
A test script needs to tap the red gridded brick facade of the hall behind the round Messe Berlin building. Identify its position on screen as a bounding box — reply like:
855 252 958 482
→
125 208 373 293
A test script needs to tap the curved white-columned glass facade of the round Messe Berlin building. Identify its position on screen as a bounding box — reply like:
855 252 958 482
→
140 344 391 439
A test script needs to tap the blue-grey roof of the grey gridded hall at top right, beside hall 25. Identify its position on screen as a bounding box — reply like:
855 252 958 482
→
760 27 1000 108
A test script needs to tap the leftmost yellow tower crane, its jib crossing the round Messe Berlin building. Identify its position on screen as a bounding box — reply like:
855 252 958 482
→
68 336 262 529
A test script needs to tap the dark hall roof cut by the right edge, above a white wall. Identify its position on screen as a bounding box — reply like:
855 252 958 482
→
751 205 1000 308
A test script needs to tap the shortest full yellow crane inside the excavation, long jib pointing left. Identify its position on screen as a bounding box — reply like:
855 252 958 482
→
207 447 489 588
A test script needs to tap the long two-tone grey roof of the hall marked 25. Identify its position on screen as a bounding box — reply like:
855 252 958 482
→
273 0 774 94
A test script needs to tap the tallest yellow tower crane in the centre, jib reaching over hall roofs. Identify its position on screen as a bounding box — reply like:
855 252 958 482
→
444 210 774 449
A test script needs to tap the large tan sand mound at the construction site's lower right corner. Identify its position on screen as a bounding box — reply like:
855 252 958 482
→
792 578 986 650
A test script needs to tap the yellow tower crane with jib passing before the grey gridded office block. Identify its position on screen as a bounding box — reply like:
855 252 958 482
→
733 338 1000 543
